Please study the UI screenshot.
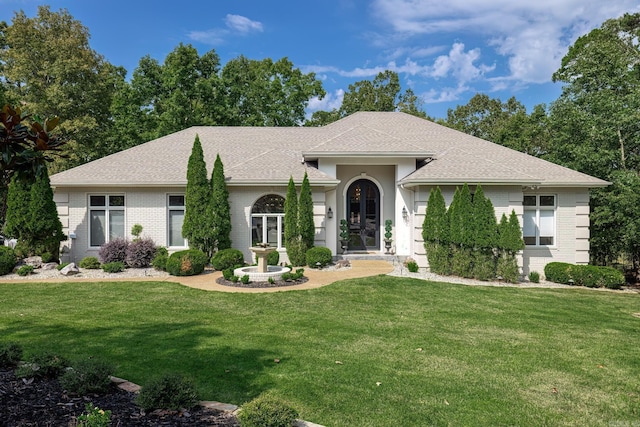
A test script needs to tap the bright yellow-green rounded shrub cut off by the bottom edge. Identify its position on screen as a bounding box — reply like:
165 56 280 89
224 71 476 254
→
238 396 298 427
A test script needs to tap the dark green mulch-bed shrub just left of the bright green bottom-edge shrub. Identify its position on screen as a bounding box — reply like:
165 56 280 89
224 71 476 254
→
136 374 198 411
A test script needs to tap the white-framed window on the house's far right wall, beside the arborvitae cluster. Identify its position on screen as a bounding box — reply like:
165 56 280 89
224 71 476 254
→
522 195 556 246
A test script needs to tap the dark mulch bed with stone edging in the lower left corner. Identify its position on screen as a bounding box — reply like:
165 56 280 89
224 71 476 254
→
0 370 240 427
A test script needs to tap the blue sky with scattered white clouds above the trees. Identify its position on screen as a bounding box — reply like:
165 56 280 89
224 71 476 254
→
0 0 640 117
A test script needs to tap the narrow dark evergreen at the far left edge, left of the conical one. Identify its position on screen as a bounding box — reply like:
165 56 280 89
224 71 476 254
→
4 175 33 251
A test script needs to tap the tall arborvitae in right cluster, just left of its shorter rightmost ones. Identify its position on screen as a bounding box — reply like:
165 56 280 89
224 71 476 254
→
473 185 498 280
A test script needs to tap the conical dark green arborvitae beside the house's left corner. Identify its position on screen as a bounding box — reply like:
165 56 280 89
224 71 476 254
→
25 169 66 260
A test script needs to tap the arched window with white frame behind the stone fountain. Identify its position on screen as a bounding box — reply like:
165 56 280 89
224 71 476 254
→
251 194 284 249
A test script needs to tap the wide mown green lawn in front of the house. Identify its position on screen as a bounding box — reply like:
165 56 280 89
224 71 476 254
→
0 276 640 427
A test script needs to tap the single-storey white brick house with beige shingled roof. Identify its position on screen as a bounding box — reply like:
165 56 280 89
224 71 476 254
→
51 112 608 274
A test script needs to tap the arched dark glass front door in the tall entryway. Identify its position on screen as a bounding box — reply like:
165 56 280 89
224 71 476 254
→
347 179 380 250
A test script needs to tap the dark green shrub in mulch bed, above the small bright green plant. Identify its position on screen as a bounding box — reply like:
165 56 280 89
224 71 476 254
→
60 359 113 395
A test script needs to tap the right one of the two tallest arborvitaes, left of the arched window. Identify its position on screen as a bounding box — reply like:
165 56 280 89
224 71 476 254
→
210 154 231 251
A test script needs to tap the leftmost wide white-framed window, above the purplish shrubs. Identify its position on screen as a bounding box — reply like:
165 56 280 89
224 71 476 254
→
89 194 125 247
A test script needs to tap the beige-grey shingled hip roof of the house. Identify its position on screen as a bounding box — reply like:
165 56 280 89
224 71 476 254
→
51 112 608 187
